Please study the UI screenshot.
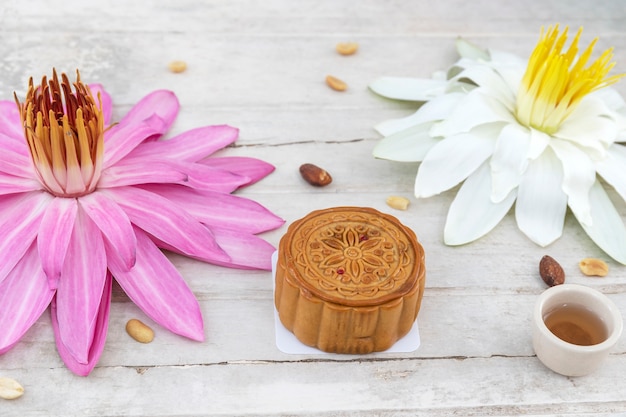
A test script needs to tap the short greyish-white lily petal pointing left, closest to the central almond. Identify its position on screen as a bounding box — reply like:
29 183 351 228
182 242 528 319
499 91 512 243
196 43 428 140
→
373 123 441 162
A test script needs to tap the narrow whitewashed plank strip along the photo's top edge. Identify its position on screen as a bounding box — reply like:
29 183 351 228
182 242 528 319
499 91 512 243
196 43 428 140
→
1 0 626 36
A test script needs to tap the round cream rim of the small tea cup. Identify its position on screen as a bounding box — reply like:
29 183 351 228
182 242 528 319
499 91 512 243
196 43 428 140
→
533 284 623 352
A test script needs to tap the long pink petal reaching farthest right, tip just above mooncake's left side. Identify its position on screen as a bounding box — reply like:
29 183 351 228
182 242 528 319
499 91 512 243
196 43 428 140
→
141 184 285 234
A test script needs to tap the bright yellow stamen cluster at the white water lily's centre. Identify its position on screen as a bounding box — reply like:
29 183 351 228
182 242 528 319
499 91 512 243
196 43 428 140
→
516 25 626 134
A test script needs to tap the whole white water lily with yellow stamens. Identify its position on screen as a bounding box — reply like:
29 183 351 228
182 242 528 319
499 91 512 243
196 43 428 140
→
370 26 626 264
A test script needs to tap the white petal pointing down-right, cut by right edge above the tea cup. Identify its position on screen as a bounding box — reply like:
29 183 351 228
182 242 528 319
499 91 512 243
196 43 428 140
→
574 181 626 265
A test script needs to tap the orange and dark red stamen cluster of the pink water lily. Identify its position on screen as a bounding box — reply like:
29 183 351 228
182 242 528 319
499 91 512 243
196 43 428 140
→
15 72 104 197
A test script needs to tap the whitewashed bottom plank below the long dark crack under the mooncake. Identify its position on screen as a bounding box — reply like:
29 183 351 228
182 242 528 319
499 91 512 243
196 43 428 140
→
3 357 626 416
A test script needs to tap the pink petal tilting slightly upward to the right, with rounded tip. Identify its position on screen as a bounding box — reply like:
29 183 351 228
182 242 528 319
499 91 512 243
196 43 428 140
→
133 125 239 162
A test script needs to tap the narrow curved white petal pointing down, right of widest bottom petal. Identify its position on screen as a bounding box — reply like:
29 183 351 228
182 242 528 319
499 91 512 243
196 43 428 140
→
550 138 596 226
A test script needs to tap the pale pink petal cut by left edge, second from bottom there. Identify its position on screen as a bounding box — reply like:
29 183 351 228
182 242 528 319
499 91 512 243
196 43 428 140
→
0 192 54 282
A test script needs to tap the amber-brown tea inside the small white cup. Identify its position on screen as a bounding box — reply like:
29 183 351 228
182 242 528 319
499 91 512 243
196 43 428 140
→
543 304 608 346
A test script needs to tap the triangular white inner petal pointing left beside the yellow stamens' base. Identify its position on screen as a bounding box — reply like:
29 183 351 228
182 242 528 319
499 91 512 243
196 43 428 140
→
431 87 517 136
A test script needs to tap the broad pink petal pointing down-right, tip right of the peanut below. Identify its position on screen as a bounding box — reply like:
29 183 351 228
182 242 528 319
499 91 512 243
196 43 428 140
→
109 229 204 341
